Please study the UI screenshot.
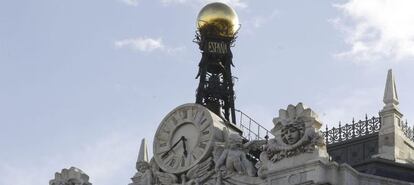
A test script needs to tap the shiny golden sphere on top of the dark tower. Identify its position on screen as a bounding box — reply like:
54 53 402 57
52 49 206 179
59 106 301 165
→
196 2 240 37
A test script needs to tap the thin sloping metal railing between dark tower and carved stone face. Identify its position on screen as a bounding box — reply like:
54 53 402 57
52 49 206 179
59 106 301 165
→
235 109 270 140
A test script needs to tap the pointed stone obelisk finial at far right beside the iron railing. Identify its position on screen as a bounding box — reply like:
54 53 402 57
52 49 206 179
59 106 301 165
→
383 69 399 109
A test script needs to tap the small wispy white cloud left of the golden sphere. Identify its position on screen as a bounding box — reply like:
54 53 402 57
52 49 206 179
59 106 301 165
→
115 37 165 52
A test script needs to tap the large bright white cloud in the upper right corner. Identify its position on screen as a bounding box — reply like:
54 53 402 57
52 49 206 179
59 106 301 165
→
332 0 414 62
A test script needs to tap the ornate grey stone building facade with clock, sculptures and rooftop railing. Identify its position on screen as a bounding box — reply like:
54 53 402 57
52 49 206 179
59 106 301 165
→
49 70 414 185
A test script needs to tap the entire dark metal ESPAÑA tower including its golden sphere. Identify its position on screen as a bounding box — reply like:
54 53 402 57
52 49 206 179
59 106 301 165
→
194 3 239 124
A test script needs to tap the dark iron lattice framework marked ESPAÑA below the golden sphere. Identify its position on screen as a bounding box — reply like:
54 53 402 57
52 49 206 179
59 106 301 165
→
194 28 236 124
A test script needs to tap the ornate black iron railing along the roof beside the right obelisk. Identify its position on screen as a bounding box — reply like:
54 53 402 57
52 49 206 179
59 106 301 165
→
322 115 381 144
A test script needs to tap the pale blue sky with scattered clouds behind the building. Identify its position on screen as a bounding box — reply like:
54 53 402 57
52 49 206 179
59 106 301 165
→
0 0 414 185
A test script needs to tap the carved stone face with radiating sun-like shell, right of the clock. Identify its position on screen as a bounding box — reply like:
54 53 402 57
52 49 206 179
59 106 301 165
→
260 103 325 163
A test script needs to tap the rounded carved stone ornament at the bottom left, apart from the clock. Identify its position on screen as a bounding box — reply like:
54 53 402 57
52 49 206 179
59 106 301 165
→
49 167 92 185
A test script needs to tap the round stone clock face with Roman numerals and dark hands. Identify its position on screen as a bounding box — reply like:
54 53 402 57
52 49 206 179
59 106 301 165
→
153 104 214 173
